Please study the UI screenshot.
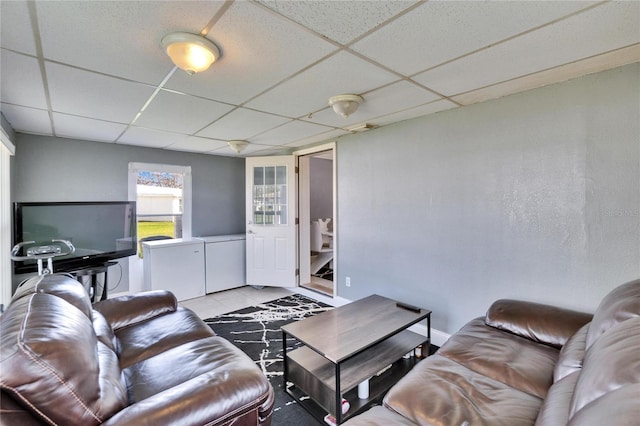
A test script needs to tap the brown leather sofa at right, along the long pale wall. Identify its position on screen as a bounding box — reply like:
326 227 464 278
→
345 280 640 426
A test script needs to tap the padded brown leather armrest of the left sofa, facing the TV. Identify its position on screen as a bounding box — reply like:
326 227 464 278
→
93 290 178 331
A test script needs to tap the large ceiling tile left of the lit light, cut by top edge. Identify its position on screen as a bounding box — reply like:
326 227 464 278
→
36 1 223 84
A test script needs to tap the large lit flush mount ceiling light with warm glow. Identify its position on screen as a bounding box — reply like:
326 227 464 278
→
161 33 220 75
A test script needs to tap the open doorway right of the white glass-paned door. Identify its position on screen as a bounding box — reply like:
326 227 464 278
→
298 144 337 297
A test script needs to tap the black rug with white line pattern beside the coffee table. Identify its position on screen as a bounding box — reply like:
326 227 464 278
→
204 294 332 426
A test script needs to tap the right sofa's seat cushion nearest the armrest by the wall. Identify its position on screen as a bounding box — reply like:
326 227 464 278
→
438 318 560 398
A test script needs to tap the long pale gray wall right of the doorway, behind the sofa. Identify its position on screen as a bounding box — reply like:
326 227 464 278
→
337 64 640 333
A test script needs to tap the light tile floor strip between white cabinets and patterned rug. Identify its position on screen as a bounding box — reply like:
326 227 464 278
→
179 286 293 319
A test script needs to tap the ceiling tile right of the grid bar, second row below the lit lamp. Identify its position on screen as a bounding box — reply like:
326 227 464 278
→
135 91 233 134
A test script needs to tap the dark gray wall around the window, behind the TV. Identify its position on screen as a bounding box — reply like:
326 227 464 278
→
12 133 245 291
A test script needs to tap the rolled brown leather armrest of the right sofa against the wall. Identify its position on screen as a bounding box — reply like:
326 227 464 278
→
485 299 592 348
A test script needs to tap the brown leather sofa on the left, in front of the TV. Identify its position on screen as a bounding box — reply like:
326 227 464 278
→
0 275 274 426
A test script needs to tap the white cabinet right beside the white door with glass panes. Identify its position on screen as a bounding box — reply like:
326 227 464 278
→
200 234 247 293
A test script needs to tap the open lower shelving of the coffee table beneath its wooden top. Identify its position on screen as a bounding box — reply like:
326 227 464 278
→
286 330 429 421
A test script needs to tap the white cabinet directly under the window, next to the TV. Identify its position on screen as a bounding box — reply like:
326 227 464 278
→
142 238 205 300
